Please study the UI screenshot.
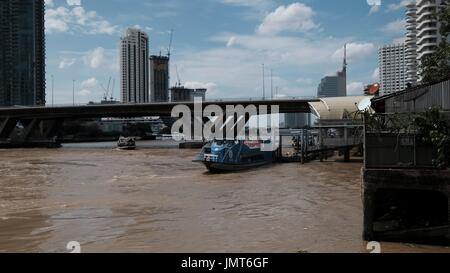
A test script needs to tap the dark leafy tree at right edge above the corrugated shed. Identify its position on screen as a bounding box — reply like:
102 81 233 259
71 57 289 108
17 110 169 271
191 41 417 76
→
419 5 450 83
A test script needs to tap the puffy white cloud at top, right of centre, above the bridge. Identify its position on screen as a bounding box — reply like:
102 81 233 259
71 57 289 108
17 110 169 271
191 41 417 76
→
257 3 318 35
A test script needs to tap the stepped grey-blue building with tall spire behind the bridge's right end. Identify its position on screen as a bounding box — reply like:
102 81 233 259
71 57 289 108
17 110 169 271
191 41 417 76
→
317 45 347 98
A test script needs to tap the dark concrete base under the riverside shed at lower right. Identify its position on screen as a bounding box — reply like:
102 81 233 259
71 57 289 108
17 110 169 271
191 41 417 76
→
362 169 450 245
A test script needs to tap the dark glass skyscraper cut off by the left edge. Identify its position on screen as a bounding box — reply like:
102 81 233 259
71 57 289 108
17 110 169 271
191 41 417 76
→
0 0 45 106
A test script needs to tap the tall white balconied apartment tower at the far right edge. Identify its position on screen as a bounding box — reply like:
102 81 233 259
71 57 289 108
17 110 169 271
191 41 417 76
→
406 0 449 84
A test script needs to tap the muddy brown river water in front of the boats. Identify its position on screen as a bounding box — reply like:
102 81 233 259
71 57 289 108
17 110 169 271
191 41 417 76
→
0 143 450 253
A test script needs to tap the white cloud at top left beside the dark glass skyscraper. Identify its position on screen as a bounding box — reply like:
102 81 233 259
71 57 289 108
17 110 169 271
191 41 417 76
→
45 0 118 35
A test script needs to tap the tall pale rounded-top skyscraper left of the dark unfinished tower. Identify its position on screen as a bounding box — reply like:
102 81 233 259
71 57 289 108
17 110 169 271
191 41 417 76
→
120 28 149 103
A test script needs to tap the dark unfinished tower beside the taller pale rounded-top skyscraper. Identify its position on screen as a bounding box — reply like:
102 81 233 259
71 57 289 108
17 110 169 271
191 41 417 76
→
150 56 169 102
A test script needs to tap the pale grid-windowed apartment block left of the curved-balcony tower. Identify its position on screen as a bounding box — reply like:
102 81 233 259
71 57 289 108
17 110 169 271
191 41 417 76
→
378 44 407 95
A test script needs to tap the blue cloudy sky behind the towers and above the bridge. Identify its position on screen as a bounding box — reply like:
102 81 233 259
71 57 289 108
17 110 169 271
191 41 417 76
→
45 0 409 104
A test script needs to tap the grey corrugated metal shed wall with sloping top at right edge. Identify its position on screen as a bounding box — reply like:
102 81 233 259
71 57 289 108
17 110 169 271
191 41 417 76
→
386 80 450 113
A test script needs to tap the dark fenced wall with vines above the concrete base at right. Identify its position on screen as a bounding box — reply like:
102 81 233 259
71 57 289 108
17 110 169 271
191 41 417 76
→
364 111 450 169
